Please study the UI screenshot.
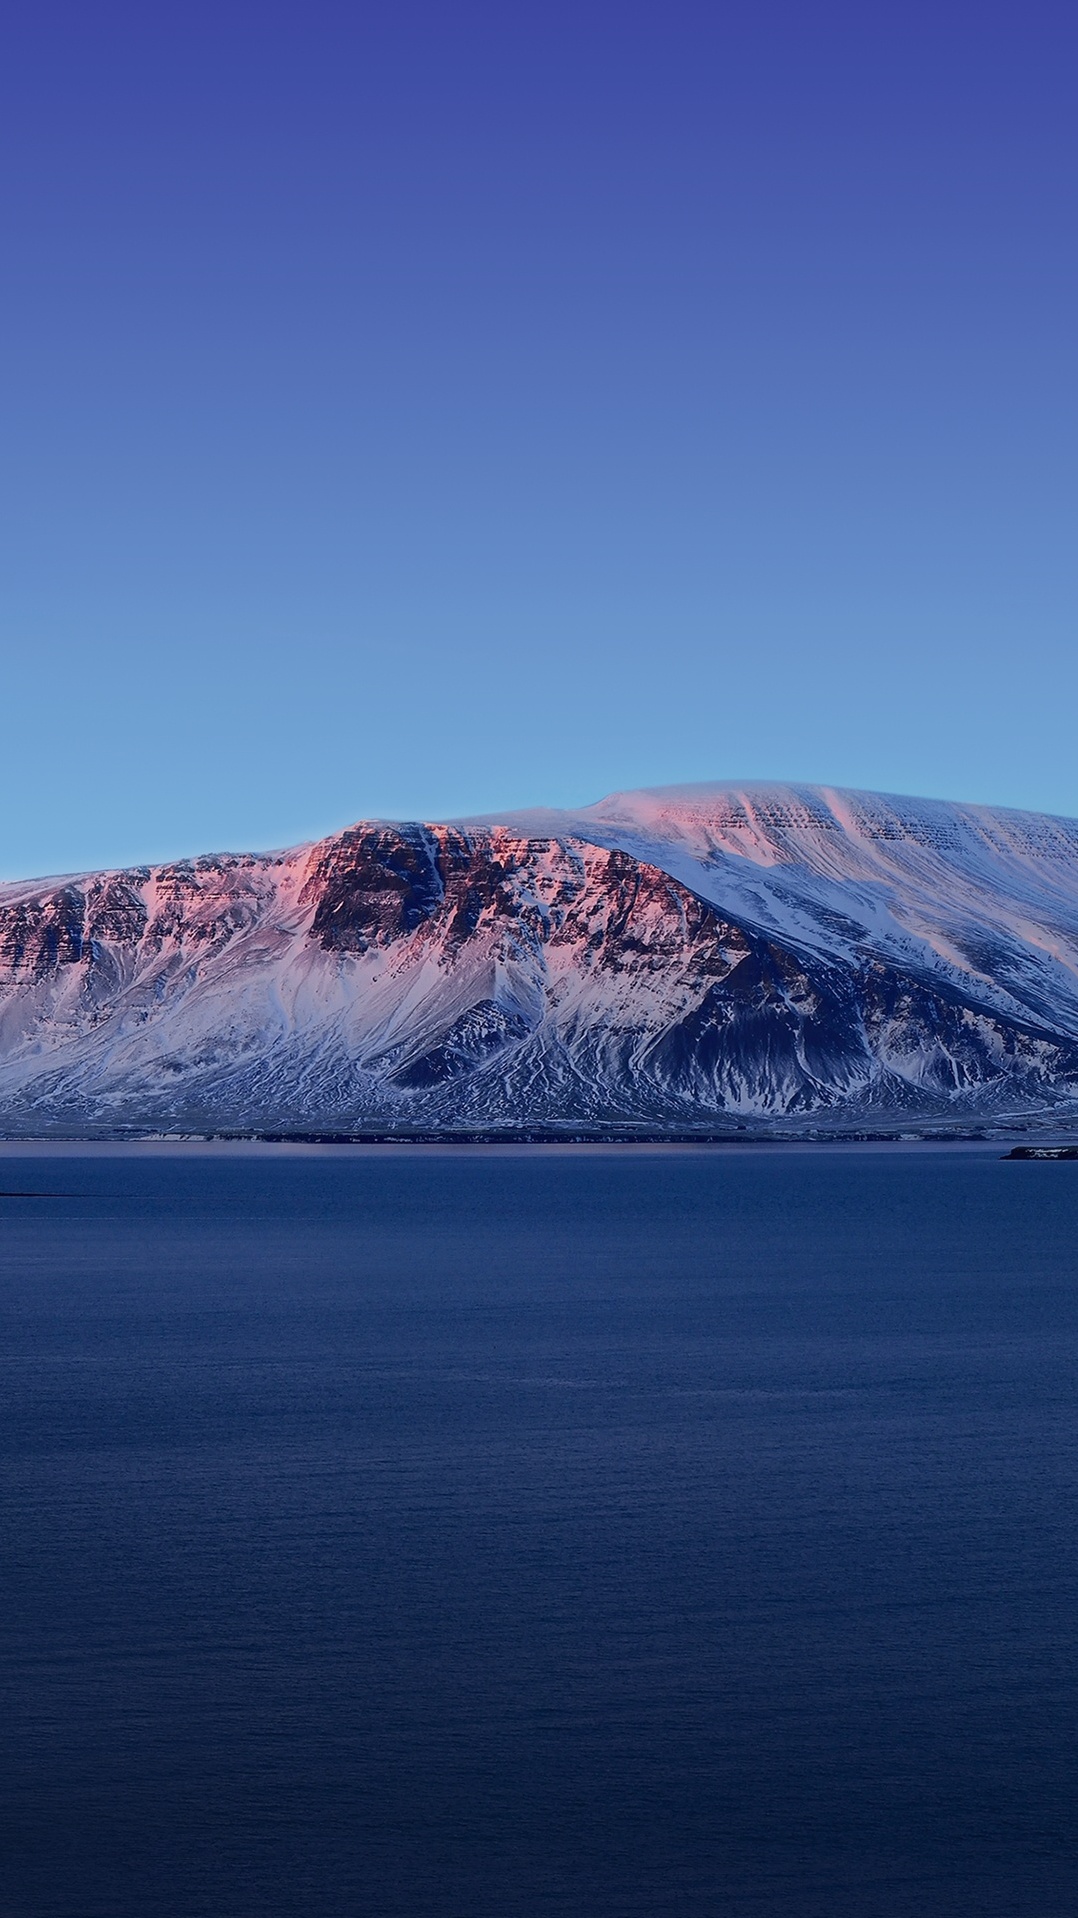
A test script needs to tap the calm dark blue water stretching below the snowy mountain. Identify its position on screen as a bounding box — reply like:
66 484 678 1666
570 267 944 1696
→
0 1149 1078 1918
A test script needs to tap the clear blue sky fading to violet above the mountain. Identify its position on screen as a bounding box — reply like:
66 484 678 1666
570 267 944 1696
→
0 0 1078 877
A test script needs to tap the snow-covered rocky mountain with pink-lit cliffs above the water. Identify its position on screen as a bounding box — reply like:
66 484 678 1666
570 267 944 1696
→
0 786 1078 1134
